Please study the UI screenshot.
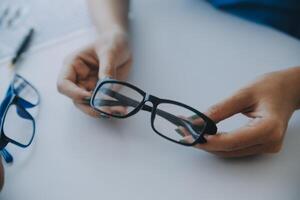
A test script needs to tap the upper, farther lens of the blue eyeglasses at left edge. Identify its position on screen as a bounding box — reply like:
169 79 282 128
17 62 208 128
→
13 76 39 105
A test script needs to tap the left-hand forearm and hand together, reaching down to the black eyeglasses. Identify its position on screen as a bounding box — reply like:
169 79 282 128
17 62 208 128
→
57 0 132 117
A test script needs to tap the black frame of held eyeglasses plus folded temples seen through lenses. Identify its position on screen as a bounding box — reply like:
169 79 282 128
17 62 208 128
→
89 77 217 146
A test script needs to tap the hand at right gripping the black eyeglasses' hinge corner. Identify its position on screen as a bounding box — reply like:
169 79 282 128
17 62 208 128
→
196 68 300 157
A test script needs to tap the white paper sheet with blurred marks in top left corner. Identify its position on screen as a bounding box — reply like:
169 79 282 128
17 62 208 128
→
0 0 91 62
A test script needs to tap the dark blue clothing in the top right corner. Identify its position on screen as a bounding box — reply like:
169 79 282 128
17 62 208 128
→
208 0 300 38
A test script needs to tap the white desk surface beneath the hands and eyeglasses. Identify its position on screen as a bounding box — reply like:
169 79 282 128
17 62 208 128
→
0 0 300 200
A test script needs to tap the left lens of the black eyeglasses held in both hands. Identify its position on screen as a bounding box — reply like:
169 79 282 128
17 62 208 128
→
93 83 143 117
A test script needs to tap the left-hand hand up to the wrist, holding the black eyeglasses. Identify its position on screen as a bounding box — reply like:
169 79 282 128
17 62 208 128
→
57 31 132 117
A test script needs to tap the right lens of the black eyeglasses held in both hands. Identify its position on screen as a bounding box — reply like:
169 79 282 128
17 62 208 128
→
154 103 205 144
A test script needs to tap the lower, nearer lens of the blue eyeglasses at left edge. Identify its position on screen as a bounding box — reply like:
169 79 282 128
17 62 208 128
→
3 105 34 145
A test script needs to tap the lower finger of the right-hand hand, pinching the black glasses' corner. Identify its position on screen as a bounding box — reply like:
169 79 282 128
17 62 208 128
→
196 119 272 151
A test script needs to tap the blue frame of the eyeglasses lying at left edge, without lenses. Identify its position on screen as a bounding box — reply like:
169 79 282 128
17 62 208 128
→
0 74 40 163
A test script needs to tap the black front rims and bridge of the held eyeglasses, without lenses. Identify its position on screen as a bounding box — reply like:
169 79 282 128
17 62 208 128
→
89 77 217 146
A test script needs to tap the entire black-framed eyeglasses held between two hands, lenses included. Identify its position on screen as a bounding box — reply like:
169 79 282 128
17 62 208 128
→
90 78 217 146
